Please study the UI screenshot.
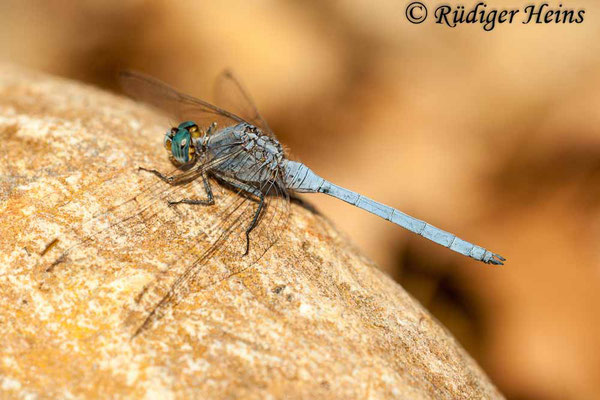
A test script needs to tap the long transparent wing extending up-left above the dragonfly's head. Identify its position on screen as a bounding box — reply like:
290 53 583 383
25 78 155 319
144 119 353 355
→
119 71 246 127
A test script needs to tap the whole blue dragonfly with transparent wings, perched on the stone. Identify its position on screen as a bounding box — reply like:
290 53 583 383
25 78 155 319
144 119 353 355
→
51 71 506 336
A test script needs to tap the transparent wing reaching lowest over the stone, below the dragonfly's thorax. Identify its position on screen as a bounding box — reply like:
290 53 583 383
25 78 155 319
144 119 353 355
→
127 159 290 336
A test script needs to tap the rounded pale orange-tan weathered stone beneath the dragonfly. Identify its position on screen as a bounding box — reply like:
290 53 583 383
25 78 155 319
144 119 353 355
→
0 66 502 399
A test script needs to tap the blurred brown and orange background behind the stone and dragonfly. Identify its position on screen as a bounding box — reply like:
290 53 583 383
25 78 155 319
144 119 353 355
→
0 0 600 399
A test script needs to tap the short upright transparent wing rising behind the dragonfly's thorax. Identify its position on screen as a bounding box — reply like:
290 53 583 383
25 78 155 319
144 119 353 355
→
214 69 275 138
